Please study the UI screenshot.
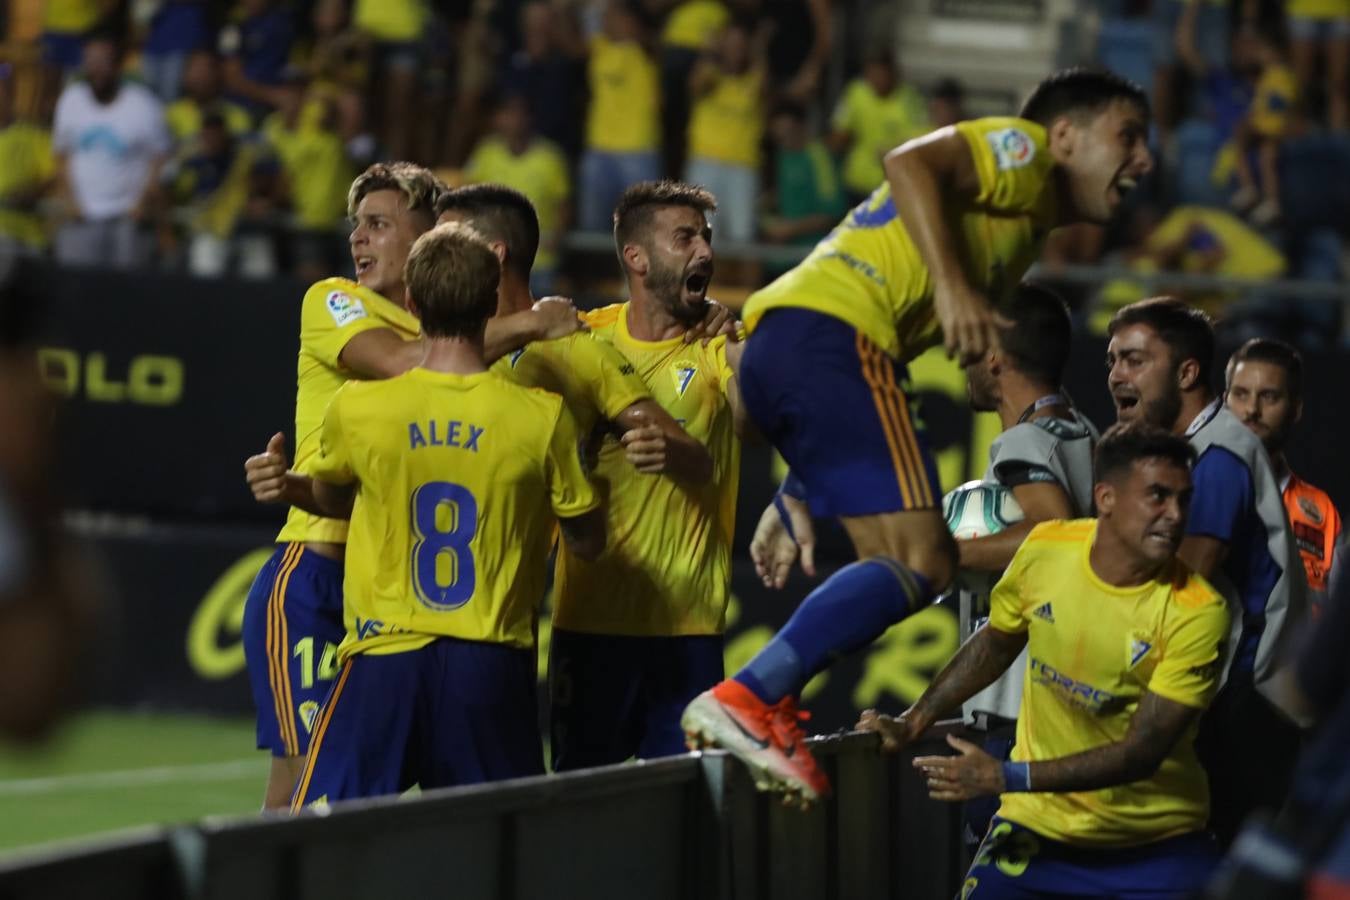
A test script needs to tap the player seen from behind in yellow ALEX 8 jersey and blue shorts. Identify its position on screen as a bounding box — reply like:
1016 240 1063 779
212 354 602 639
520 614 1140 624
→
279 225 605 810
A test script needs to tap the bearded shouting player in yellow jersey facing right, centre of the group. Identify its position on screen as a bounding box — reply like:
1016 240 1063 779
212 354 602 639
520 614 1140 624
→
549 181 741 770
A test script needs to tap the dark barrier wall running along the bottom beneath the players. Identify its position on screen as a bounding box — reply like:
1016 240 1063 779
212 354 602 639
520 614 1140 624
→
0 726 967 900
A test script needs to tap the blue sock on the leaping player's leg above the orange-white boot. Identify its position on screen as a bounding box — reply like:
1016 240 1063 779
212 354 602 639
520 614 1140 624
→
733 556 933 703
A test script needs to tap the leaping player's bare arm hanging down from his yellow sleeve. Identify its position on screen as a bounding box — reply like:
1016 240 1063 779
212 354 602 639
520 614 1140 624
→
884 127 1010 363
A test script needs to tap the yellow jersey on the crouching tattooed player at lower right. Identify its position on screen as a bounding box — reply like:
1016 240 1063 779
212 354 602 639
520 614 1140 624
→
990 519 1229 846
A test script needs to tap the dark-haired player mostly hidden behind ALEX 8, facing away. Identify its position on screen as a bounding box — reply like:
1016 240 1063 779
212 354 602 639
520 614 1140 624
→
436 185 713 480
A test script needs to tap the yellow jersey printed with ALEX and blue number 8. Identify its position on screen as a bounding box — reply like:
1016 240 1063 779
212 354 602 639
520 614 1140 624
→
311 368 599 660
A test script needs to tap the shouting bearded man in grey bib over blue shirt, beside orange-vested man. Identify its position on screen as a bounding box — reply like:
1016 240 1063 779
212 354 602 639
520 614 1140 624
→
1107 297 1307 842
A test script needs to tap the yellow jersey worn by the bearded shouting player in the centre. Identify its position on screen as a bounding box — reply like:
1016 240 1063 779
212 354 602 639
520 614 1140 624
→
554 304 741 637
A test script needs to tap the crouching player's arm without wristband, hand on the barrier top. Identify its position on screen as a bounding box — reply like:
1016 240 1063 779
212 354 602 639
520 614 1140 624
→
857 625 1026 752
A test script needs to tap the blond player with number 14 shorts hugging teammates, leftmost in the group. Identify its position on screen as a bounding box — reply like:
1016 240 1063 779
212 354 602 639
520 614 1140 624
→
243 163 591 808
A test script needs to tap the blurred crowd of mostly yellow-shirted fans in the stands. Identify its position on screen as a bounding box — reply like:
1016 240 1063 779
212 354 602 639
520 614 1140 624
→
0 0 1350 343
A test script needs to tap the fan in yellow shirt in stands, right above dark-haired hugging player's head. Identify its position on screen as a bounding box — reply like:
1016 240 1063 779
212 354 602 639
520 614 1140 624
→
464 94 572 294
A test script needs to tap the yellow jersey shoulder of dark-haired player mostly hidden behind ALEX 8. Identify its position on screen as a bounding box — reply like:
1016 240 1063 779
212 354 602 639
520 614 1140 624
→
493 333 652 440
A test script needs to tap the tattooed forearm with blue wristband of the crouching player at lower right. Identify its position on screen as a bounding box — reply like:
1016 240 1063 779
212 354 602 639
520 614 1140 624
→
914 691 1200 800
